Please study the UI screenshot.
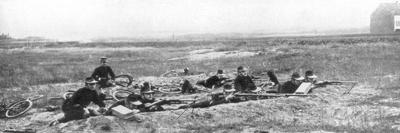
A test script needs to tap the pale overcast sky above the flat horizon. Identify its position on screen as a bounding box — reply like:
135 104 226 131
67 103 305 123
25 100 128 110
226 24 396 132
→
0 0 387 40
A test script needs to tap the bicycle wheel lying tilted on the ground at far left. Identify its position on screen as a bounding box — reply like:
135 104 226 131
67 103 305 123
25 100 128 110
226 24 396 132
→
6 100 33 118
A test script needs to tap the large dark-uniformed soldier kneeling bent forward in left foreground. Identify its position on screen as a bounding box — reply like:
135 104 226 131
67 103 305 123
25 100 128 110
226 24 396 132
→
50 78 105 125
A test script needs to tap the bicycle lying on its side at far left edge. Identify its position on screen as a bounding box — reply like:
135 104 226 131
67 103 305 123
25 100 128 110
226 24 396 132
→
0 95 44 118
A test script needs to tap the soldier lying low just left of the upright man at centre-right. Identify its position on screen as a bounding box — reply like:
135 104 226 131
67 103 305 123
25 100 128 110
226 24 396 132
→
196 70 228 88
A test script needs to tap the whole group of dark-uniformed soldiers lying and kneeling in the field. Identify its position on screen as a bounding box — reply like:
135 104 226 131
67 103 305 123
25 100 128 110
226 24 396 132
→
50 57 317 125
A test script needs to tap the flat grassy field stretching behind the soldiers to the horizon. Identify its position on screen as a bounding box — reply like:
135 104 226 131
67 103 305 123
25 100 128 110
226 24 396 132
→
0 36 400 87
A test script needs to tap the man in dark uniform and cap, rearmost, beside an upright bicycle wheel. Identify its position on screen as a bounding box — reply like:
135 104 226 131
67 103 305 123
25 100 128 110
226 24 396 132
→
91 57 115 88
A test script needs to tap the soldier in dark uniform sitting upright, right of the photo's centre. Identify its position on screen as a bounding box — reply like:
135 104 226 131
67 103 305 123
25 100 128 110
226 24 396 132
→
234 66 257 93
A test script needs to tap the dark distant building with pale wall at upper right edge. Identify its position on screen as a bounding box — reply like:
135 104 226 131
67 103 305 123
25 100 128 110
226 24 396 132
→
370 2 400 34
